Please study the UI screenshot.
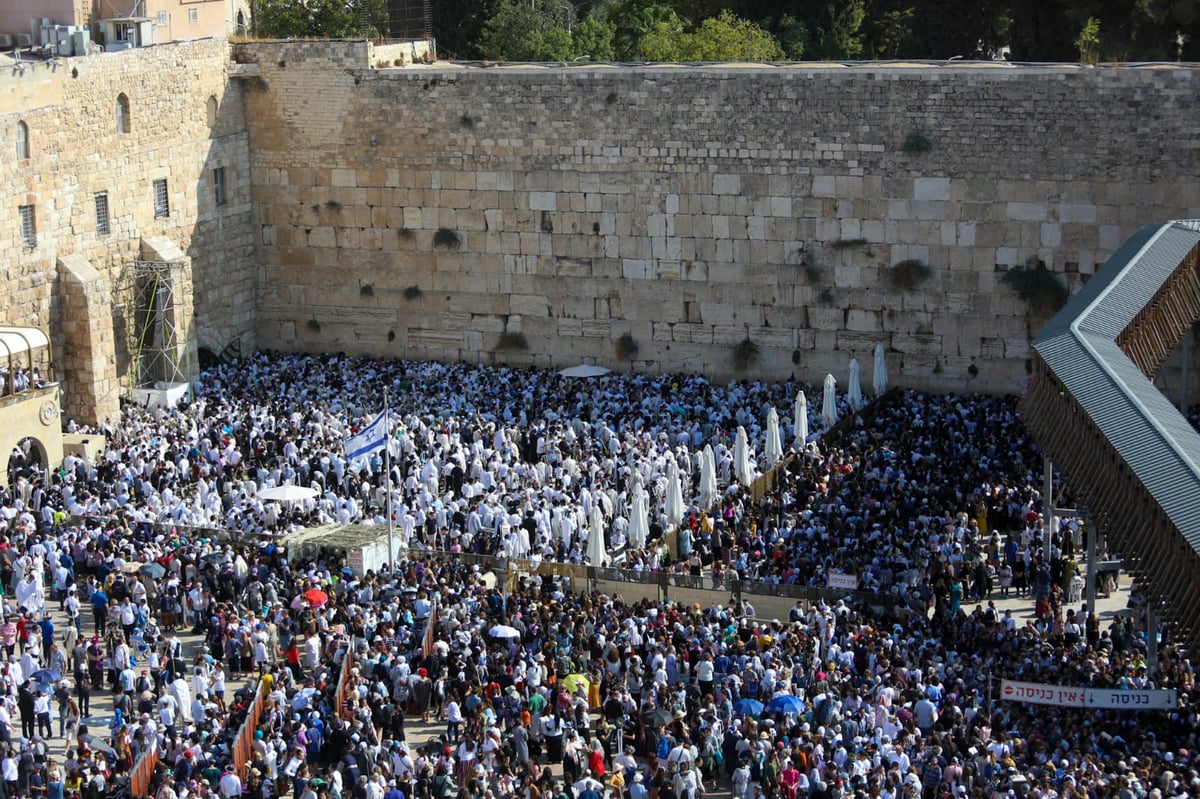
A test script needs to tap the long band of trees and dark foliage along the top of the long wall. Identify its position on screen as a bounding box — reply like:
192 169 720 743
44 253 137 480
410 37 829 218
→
427 0 1200 61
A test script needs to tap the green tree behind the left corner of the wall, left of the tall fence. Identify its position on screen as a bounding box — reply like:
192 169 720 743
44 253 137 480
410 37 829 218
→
253 0 388 38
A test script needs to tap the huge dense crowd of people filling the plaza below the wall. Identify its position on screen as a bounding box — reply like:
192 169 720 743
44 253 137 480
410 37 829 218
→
0 355 1200 799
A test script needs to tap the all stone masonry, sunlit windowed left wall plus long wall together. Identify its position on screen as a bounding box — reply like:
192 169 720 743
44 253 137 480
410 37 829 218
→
0 41 1200 421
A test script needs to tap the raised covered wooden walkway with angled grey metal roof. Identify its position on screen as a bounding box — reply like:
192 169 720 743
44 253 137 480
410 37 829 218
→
1021 222 1200 655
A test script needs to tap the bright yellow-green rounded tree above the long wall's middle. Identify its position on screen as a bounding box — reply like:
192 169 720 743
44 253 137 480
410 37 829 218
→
641 11 784 61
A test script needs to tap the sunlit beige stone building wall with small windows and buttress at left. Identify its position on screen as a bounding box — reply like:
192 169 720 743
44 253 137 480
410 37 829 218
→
0 40 254 421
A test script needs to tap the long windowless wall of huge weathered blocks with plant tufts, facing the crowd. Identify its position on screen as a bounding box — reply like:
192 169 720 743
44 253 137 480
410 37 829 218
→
235 42 1200 391
